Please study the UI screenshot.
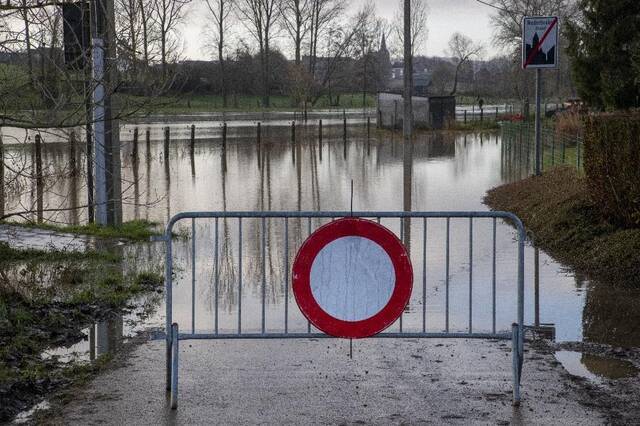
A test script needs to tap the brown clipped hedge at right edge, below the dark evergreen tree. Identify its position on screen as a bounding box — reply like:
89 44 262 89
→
584 111 640 227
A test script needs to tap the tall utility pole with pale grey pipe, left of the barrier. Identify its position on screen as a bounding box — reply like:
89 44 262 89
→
91 0 122 226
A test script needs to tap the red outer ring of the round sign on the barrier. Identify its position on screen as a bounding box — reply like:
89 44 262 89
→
292 218 413 339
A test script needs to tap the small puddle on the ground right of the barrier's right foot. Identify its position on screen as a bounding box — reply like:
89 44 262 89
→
555 351 639 383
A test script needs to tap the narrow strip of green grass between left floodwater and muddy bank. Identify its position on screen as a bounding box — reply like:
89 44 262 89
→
5 220 160 241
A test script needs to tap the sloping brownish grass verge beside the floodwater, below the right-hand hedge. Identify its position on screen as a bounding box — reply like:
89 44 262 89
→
485 167 640 288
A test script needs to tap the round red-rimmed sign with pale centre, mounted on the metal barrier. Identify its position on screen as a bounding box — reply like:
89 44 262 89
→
293 218 413 339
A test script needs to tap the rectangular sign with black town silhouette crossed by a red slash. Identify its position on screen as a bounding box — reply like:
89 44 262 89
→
522 16 558 69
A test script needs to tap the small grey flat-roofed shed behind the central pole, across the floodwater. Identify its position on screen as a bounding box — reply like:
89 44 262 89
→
378 92 456 129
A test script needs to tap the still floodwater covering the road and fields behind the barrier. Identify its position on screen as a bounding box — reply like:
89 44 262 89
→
5 119 640 352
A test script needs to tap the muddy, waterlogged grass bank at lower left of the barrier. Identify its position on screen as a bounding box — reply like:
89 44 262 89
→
0 259 164 423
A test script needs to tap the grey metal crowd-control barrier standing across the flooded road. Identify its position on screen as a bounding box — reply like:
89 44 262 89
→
160 212 526 409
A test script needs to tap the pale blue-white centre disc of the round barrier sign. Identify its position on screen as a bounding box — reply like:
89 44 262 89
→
310 236 396 321
